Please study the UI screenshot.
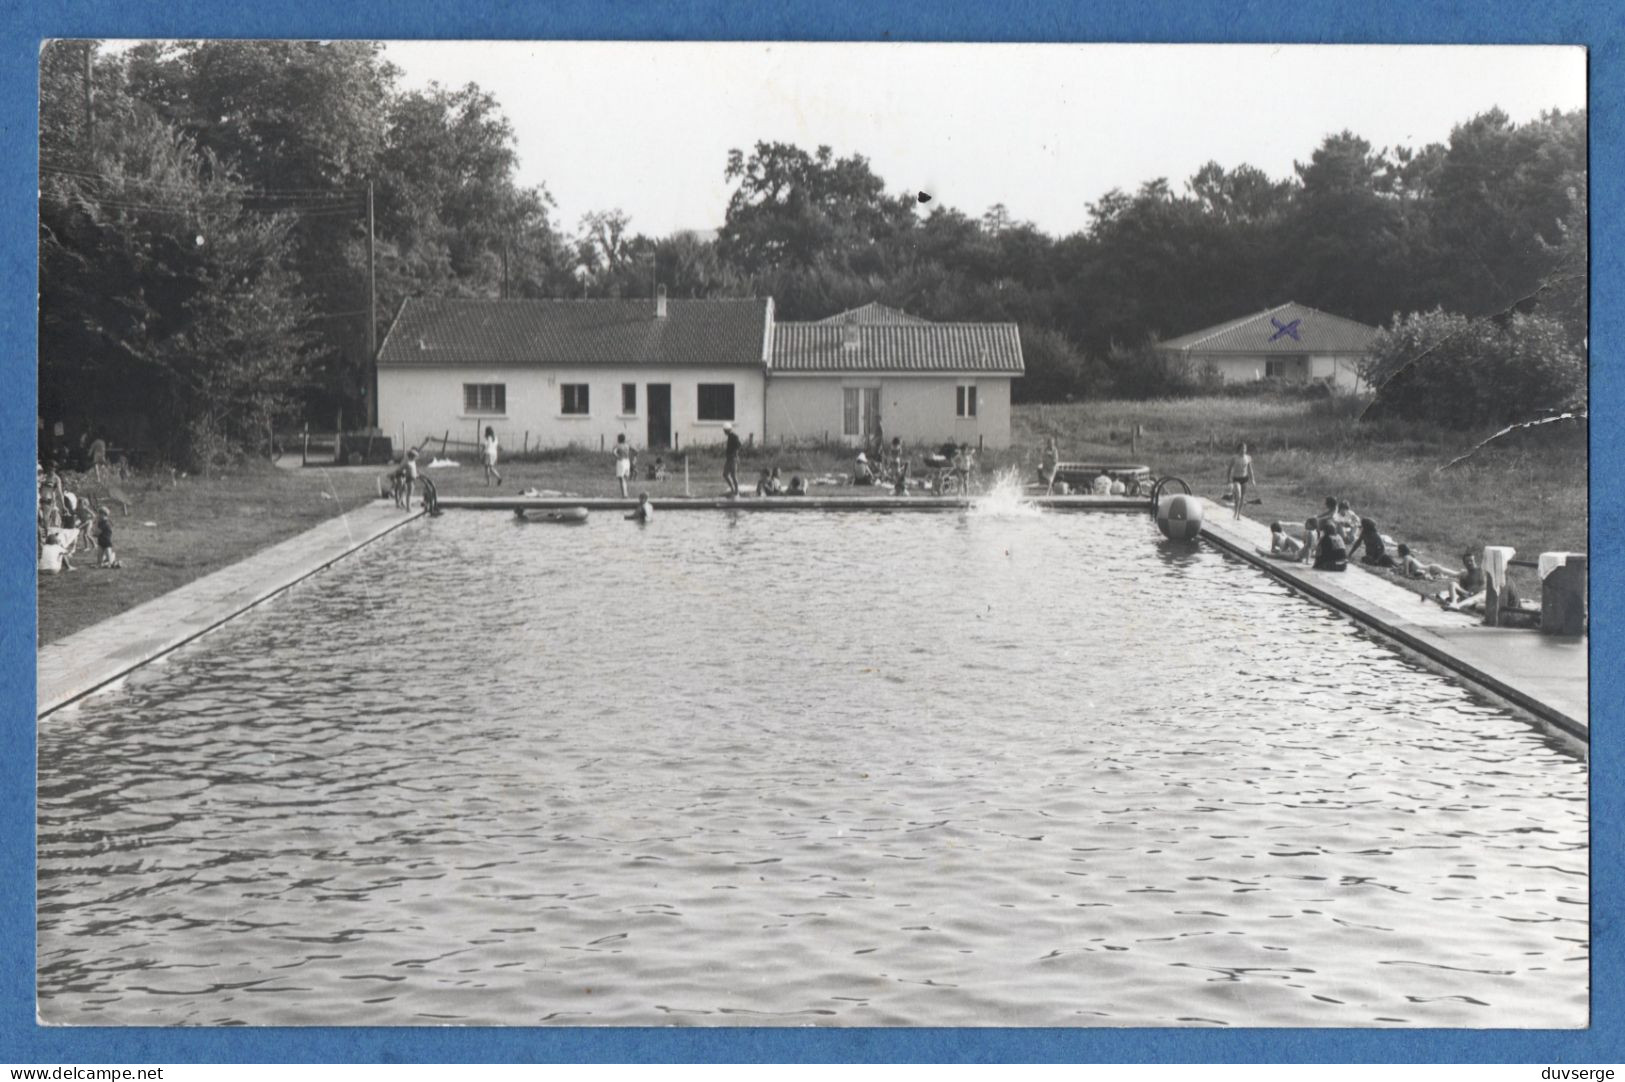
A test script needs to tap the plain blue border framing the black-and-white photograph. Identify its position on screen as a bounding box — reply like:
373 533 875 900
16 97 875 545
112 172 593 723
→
0 0 1625 1064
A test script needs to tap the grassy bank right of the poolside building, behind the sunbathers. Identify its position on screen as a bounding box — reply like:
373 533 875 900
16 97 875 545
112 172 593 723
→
1014 398 1588 596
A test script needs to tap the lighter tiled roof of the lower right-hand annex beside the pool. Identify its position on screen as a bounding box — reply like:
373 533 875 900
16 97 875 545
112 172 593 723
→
770 322 1025 375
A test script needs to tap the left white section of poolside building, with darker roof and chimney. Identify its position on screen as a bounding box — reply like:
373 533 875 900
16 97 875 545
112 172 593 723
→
379 290 774 452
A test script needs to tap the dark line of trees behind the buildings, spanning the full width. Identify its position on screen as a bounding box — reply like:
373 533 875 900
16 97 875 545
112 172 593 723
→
39 41 1588 461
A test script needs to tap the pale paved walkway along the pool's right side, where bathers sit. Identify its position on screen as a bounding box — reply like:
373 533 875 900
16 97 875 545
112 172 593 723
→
1203 500 1591 739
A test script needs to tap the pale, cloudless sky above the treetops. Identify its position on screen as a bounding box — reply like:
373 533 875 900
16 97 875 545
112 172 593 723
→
385 42 1586 236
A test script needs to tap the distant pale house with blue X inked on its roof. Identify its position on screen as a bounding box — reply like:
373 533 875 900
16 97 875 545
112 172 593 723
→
1157 301 1376 390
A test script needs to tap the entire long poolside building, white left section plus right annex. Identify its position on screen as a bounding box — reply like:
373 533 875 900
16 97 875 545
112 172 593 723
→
379 296 1022 452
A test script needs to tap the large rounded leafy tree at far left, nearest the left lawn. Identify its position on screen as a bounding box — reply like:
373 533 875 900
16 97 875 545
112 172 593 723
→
39 99 310 468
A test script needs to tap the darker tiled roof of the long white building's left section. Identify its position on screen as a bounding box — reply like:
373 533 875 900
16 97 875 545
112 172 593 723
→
379 297 770 367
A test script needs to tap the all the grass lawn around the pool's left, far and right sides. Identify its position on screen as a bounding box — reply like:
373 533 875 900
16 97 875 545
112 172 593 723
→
39 398 1586 643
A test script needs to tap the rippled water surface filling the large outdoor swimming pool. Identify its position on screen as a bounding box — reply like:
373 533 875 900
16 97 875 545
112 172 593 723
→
39 512 1588 1027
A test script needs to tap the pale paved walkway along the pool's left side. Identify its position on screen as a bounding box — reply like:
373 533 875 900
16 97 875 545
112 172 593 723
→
37 500 423 716
